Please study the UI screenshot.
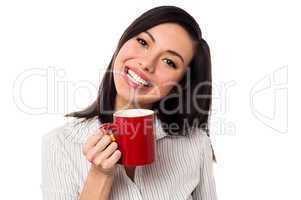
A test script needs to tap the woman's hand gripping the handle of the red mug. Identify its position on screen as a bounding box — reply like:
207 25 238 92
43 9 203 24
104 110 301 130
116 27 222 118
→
83 128 121 175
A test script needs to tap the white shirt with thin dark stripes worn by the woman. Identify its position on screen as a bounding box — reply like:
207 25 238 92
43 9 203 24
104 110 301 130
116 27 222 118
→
41 117 217 200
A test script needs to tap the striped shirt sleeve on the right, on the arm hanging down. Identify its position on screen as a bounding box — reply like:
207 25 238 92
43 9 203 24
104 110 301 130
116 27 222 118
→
192 136 217 200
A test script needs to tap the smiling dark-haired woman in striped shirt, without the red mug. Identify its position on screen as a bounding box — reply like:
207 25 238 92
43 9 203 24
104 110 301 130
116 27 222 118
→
41 6 216 200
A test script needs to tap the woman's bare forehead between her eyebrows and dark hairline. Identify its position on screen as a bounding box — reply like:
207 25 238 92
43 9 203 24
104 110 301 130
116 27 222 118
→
147 23 194 63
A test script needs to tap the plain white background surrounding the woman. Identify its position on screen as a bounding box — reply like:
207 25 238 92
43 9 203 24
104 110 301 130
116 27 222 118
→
0 0 301 200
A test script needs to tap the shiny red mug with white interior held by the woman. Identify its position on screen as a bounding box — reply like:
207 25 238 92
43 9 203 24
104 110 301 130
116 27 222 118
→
100 109 156 166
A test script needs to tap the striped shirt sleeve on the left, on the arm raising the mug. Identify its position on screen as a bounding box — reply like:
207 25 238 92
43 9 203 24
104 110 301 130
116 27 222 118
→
41 129 79 200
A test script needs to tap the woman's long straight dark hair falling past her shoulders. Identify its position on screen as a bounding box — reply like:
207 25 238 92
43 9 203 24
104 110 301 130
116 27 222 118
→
65 6 215 160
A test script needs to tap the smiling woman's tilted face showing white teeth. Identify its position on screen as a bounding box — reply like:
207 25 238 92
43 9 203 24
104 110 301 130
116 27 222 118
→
113 23 194 108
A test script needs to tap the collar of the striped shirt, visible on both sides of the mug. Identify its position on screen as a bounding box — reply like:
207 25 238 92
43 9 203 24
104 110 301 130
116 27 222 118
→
64 115 167 143
